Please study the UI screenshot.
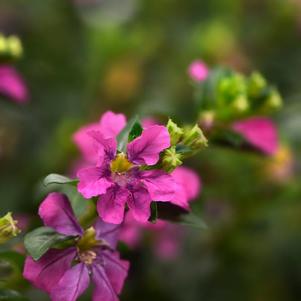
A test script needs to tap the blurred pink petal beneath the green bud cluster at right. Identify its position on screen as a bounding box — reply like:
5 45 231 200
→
232 116 278 155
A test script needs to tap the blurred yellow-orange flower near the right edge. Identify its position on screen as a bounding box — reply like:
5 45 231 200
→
264 145 294 183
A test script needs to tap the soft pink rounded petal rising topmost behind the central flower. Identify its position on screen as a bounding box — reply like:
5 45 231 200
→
99 111 126 138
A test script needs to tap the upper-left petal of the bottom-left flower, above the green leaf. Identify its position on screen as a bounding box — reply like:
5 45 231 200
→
39 192 83 236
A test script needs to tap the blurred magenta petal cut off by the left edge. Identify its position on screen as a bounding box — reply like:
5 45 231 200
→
0 65 28 103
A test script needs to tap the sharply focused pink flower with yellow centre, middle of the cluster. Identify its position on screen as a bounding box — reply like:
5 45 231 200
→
78 112 175 224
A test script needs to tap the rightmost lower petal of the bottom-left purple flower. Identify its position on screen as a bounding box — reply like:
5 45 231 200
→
102 251 130 294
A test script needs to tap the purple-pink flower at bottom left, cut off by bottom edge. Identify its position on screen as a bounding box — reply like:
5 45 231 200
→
23 193 129 301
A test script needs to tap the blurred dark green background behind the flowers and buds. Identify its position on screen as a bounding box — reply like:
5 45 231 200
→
0 0 301 301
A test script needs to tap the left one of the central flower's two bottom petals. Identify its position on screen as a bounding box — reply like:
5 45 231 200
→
97 185 129 224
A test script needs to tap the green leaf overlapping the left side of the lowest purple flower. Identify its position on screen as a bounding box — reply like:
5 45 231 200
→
24 227 70 260
